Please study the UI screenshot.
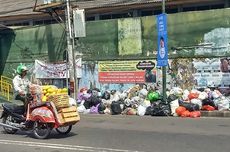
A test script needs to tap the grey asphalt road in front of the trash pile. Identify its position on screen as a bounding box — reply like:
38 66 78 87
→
0 115 230 152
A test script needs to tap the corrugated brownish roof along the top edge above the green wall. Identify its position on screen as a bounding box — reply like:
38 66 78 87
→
0 0 224 19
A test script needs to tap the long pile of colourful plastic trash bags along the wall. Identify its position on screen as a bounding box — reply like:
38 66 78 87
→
77 85 230 118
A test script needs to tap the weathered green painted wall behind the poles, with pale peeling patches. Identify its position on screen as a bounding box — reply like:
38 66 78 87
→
0 9 230 89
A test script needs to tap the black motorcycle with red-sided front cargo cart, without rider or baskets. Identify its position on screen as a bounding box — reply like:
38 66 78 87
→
0 94 77 139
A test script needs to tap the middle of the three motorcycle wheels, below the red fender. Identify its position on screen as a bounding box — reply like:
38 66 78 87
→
33 121 52 139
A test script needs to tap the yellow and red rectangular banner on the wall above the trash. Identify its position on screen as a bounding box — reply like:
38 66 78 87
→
98 61 156 83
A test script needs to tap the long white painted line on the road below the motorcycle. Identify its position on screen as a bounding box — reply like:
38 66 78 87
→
0 139 144 152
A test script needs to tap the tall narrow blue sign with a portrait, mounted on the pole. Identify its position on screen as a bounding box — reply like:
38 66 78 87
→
157 14 168 66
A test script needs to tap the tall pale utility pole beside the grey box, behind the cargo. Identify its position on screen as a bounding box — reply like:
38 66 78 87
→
65 0 77 100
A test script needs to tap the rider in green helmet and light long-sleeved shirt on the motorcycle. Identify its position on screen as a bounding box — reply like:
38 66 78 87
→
13 64 31 105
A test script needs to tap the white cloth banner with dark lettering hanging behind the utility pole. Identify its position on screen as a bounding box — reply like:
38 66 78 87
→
35 59 82 79
